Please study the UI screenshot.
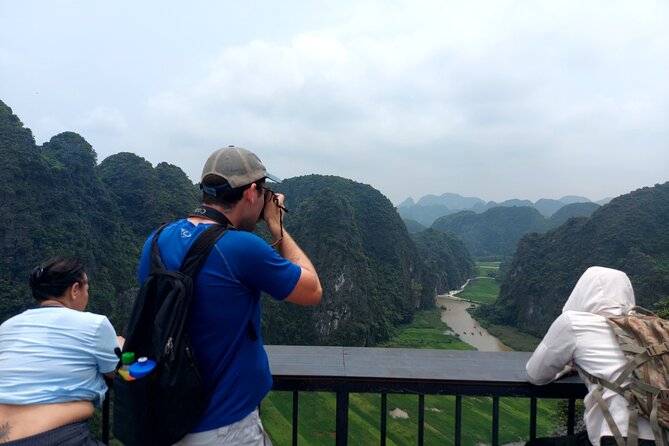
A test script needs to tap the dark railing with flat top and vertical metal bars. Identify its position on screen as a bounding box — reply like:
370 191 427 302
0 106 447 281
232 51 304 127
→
103 346 586 446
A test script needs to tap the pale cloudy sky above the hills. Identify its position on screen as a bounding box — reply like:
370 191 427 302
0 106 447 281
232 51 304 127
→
0 0 669 204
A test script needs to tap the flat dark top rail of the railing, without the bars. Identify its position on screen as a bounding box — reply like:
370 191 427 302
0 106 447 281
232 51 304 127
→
266 345 585 398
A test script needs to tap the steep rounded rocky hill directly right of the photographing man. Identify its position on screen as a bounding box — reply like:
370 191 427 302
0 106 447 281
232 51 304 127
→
258 175 434 345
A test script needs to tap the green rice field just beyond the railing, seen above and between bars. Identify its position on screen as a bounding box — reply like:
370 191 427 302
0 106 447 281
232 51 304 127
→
261 298 558 446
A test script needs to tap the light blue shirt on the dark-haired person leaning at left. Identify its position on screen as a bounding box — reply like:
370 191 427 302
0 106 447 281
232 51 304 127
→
0 307 119 406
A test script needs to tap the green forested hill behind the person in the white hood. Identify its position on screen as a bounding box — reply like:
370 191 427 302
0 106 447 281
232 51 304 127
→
477 182 669 336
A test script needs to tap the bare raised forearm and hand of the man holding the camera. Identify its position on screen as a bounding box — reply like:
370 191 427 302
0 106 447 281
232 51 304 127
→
264 194 323 305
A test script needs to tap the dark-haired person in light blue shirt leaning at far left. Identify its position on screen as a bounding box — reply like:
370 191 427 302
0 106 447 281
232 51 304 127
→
0 257 123 446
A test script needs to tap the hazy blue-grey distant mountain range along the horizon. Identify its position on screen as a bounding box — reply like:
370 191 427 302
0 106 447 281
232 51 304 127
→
397 192 612 227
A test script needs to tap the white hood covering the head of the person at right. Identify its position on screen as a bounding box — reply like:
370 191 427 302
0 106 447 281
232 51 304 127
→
562 266 635 315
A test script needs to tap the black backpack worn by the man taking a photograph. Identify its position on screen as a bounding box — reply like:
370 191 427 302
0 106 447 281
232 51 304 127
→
113 225 227 446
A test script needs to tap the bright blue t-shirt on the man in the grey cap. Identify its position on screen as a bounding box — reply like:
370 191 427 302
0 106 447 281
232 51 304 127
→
139 219 302 432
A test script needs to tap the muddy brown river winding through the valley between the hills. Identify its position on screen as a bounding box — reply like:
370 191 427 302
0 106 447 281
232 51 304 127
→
437 280 513 352
